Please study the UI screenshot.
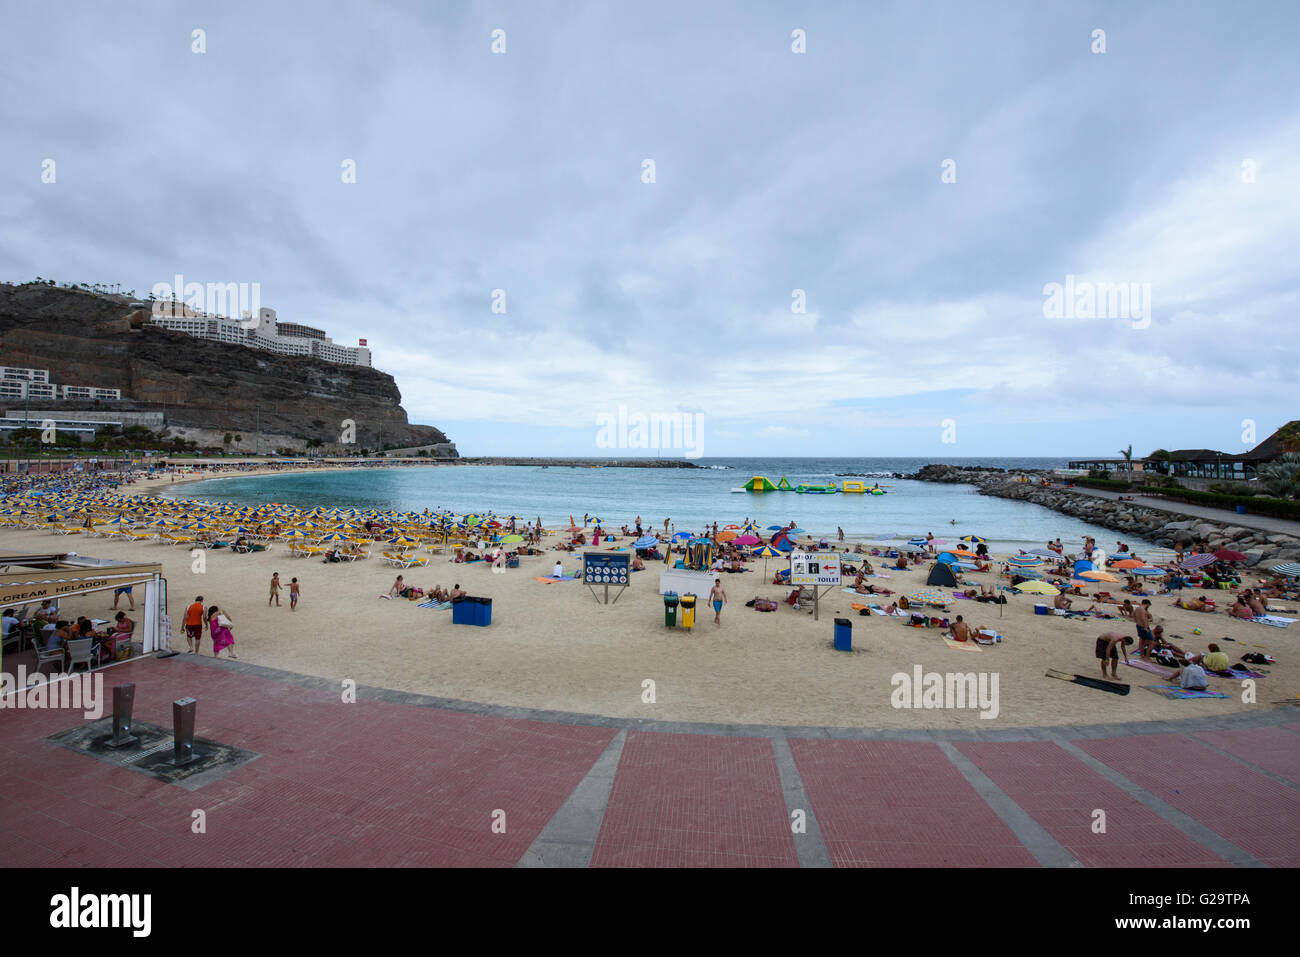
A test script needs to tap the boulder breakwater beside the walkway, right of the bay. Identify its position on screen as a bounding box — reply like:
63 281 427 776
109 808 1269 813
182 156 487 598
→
907 465 1300 566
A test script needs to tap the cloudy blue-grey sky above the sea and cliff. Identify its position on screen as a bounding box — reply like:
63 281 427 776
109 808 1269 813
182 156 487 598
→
0 0 1300 458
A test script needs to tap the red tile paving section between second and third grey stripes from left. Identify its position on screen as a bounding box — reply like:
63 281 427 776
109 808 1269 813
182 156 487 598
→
790 739 1037 867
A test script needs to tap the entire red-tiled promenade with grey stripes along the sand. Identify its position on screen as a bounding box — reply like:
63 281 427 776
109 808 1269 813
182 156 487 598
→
0 655 1300 867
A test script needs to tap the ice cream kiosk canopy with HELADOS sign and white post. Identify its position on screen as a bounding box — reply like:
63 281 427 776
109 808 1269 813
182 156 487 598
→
0 553 170 654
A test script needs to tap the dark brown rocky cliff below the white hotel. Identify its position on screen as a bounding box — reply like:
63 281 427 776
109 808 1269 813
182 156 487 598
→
0 283 447 451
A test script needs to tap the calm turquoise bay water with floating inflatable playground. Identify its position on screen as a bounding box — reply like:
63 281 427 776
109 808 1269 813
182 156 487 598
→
168 459 1151 551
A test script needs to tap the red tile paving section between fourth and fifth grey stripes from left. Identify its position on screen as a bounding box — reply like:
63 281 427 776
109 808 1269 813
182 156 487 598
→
1075 735 1300 867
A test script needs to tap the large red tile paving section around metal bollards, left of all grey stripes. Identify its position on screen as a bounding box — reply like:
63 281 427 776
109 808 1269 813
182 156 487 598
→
0 659 615 866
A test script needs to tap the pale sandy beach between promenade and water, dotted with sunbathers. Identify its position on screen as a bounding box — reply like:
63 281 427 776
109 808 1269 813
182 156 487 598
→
0 488 1300 729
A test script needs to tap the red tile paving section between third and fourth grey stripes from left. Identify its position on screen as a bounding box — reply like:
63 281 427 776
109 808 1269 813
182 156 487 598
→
957 741 1229 867
